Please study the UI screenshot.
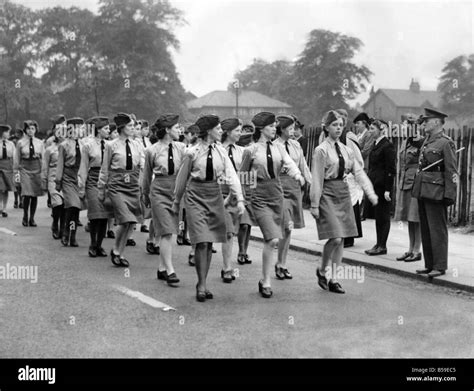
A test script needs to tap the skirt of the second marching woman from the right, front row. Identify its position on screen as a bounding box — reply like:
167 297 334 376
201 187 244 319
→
250 178 283 241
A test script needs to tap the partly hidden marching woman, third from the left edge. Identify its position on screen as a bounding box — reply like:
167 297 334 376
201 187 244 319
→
41 121 66 239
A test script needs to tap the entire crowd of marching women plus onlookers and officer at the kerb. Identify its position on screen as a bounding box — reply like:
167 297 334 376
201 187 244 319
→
0 108 457 302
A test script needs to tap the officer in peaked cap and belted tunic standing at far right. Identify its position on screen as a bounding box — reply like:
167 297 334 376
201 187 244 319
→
412 108 457 278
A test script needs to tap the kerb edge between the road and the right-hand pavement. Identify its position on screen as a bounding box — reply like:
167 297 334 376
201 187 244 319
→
250 235 474 293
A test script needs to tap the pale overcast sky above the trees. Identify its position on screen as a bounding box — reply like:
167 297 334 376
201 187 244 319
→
11 0 474 104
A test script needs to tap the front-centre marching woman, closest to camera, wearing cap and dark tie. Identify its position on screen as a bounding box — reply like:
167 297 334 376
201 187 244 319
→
173 115 245 302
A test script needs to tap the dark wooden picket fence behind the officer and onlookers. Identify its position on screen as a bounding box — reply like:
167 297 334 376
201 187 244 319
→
303 126 474 226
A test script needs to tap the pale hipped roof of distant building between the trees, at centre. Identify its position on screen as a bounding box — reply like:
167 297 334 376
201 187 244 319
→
187 90 291 109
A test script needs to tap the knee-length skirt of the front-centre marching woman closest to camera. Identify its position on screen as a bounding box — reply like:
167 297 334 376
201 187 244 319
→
185 179 227 244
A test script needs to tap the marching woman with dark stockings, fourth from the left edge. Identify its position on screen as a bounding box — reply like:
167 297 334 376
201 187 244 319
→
56 118 84 247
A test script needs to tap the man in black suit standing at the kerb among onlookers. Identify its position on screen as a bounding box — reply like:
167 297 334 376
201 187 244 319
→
365 120 397 255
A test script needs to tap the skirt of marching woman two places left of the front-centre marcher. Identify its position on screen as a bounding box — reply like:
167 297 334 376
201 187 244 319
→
107 169 143 224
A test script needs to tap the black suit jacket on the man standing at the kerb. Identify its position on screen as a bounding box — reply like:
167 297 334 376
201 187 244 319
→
369 137 397 193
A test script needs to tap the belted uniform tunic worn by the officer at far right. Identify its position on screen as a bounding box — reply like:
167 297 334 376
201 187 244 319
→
412 132 457 205
